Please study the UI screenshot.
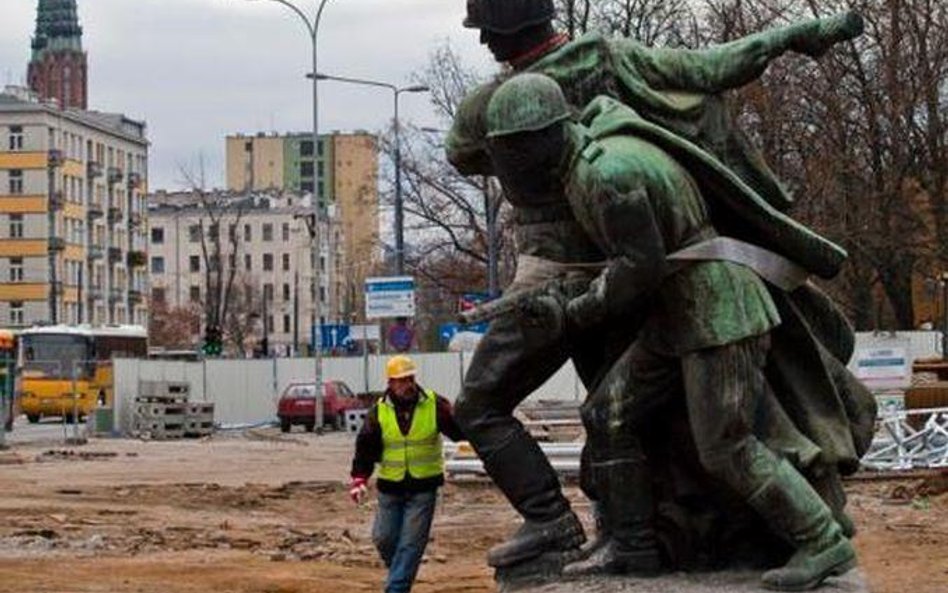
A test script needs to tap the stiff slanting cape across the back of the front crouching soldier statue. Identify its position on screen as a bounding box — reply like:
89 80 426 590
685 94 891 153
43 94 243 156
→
580 96 847 279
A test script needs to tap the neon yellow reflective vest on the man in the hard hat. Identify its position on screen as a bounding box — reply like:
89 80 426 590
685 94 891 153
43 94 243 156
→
378 390 444 482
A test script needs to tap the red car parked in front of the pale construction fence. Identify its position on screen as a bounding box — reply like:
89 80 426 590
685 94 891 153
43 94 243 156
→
277 381 368 432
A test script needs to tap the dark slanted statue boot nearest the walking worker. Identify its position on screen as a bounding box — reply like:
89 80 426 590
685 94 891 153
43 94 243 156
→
483 430 586 568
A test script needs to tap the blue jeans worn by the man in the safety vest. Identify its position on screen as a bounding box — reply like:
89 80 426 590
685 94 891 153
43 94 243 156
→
372 490 437 593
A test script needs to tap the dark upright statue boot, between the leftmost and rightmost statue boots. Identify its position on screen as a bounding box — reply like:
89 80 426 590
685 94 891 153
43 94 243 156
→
563 459 662 577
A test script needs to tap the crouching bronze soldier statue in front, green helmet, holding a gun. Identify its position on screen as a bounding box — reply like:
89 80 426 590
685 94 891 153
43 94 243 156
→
486 74 875 591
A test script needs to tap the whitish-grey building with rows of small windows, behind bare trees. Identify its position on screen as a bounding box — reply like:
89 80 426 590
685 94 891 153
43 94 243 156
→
149 192 349 354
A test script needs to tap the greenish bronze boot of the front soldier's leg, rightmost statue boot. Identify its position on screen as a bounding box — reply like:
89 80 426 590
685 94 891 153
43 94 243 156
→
748 460 856 591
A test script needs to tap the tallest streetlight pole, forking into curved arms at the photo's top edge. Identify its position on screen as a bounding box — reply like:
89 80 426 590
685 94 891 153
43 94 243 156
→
248 0 332 432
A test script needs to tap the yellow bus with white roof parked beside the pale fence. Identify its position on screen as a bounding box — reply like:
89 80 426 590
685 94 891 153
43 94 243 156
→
18 325 148 423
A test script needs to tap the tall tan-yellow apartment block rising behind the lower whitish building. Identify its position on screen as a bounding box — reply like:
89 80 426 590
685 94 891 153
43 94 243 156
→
226 132 382 321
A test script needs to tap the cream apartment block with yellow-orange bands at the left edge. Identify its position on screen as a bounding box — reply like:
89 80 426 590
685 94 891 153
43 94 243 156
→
0 87 148 326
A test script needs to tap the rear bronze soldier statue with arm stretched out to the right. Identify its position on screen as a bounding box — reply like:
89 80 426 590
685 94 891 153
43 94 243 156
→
447 0 862 572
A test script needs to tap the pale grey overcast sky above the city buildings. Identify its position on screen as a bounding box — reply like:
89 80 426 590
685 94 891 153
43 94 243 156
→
0 0 495 190
